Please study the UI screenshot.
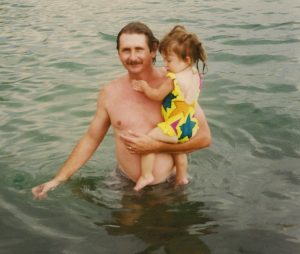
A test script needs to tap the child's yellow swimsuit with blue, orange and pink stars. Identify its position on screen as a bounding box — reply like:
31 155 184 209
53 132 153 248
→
157 72 199 143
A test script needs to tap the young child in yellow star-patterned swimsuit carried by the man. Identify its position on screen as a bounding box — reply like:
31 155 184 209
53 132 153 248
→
132 26 207 191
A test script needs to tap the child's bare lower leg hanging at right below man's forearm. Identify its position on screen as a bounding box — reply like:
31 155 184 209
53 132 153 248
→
173 153 189 185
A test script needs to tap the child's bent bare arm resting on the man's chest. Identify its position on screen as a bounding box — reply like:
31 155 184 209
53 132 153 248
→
132 79 173 101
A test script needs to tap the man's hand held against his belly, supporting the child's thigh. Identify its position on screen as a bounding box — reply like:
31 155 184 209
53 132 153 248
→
120 131 159 154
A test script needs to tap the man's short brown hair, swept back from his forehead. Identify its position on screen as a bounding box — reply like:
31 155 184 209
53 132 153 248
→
117 22 159 62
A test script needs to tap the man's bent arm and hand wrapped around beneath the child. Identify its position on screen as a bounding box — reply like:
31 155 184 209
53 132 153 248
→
121 105 211 154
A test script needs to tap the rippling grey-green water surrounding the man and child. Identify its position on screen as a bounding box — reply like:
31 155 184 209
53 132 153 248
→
0 0 300 254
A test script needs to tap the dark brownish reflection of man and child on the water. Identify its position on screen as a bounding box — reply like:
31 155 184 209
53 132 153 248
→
72 175 217 254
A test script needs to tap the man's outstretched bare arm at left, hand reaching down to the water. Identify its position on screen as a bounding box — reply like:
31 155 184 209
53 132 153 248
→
32 89 110 199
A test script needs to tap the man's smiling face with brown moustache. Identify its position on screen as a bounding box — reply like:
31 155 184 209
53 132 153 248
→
118 33 156 74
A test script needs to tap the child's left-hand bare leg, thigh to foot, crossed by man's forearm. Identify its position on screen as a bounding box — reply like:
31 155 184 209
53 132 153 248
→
134 128 177 191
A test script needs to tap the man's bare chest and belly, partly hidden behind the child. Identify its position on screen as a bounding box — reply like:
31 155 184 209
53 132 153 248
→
105 72 173 183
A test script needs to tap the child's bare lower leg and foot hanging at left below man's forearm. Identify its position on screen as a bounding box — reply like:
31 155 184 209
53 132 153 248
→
134 153 155 191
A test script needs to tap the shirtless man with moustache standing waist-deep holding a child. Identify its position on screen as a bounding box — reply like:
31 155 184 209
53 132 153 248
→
32 22 211 199
